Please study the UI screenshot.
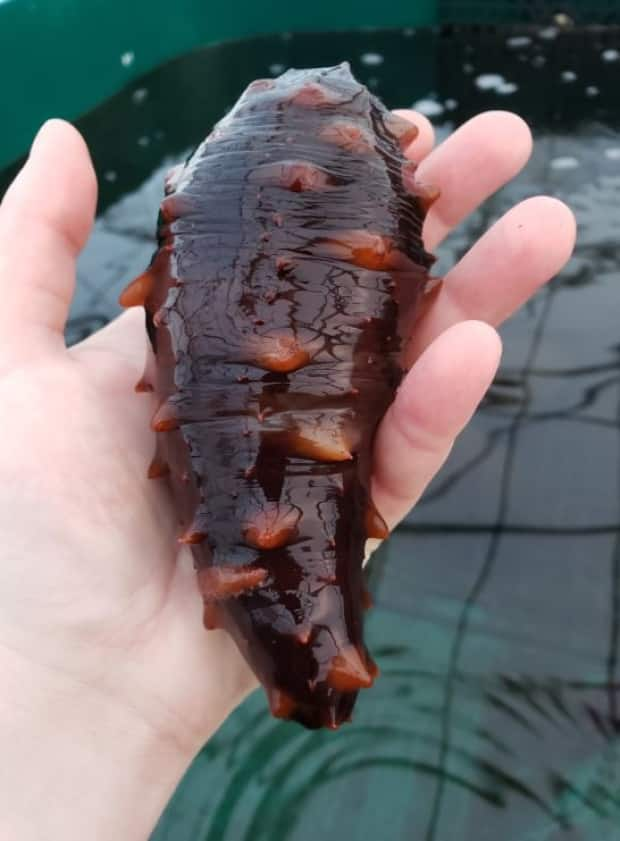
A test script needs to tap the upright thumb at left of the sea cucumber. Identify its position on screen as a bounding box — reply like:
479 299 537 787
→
0 120 97 370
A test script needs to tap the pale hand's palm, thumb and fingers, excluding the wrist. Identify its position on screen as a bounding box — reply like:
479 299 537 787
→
0 114 574 746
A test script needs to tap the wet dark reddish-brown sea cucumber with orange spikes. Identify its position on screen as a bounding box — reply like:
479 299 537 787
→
121 63 436 728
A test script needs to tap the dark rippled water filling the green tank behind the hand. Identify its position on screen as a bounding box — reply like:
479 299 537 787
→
0 23 620 841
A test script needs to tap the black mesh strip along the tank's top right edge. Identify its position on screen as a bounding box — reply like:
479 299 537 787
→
439 0 620 24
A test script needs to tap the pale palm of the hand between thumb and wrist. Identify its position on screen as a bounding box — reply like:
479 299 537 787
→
0 332 253 741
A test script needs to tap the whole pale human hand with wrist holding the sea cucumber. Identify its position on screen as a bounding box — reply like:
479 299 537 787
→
0 112 575 841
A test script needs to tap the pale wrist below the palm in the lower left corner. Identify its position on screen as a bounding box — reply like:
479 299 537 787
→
0 640 193 841
